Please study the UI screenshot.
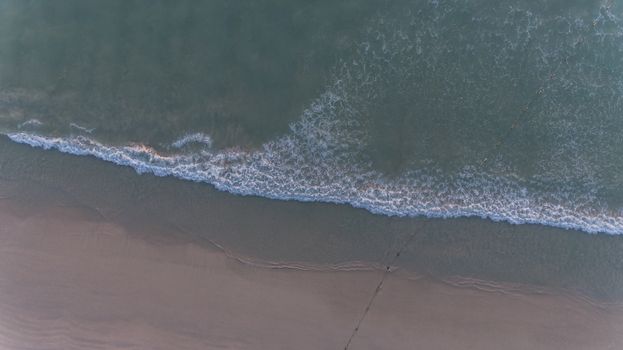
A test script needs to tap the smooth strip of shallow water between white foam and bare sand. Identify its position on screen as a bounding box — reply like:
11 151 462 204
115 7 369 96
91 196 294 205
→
0 138 623 302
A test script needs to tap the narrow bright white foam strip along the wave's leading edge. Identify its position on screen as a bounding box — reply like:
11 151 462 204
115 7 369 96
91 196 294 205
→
2 131 623 235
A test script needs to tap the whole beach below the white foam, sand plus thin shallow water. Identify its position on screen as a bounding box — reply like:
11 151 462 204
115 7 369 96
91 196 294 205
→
0 139 623 349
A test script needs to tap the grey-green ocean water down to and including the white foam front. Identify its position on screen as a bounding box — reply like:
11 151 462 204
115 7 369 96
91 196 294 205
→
0 0 623 234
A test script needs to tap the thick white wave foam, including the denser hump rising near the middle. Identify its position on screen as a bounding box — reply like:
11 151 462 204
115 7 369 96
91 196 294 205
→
8 88 623 234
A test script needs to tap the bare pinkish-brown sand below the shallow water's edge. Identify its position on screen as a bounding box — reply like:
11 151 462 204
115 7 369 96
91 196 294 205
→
0 199 623 349
